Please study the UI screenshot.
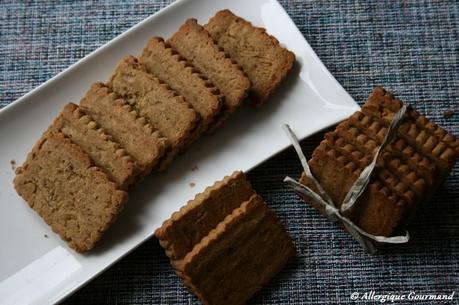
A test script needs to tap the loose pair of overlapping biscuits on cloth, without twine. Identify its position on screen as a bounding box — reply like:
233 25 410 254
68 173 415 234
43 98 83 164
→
155 172 295 305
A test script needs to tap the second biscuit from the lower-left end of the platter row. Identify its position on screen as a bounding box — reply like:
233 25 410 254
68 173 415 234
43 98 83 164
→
50 103 139 189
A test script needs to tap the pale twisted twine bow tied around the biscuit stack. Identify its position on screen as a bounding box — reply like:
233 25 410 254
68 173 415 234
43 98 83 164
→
283 104 410 253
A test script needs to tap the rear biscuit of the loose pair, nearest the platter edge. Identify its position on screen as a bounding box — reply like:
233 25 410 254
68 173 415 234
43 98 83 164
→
155 171 254 259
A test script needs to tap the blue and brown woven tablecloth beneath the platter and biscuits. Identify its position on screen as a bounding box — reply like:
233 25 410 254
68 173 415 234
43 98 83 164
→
0 0 459 304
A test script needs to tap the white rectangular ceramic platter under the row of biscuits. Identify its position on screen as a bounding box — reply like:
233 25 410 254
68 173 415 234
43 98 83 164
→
0 0 358 304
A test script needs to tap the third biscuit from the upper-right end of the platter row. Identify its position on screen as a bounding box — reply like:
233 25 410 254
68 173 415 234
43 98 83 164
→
139 37 223 133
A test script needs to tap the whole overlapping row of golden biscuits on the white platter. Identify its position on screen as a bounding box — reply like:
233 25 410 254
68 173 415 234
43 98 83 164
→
14 10 295 252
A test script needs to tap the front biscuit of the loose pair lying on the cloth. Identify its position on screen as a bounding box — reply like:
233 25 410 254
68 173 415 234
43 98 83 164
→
173 195 295 305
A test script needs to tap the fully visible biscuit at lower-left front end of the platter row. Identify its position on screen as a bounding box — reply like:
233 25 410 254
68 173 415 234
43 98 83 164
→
14 132 128 252
